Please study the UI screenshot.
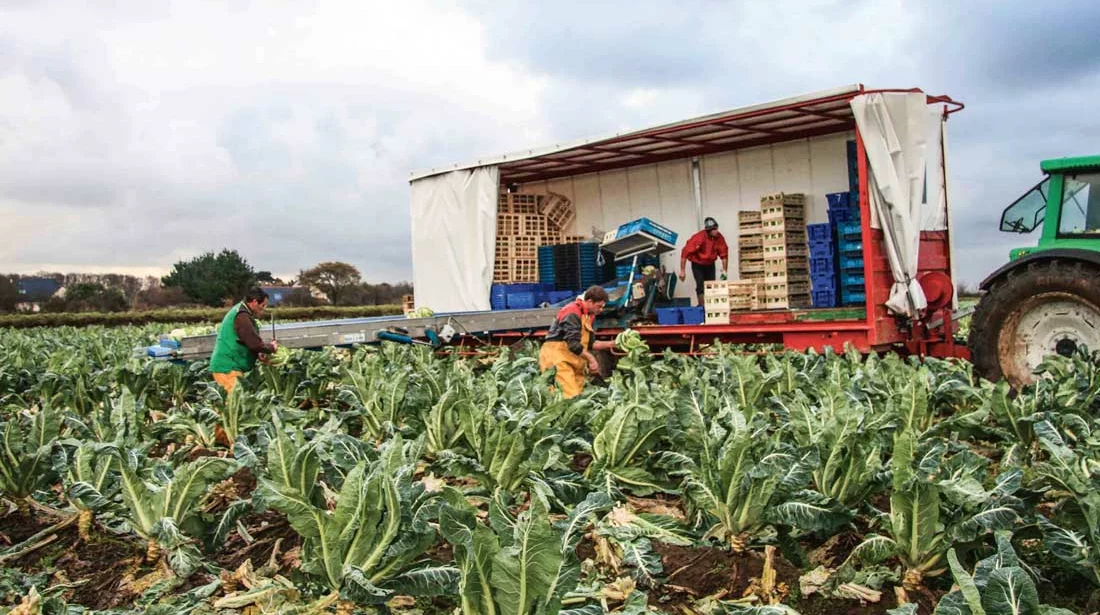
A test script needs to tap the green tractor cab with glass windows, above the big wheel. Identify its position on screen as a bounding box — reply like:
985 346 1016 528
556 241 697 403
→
1001 156 1100 261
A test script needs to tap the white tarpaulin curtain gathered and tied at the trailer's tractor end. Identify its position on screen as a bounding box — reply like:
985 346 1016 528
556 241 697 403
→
851 92 947 317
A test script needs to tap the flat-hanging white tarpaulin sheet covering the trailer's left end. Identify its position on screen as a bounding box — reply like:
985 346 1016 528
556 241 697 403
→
411 166 501 312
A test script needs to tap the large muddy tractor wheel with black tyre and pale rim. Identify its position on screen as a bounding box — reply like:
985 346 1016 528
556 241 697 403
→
967 259 1100 388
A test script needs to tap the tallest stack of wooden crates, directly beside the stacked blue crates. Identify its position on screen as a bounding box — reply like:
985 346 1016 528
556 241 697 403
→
760 193 811 309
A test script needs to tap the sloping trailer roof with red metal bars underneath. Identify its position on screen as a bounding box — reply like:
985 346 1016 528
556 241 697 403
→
413 85 963 185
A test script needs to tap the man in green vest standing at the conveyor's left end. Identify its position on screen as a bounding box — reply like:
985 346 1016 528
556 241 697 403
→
210 288 278 394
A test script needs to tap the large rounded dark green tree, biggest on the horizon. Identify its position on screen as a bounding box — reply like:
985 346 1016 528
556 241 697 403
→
162 250 256 306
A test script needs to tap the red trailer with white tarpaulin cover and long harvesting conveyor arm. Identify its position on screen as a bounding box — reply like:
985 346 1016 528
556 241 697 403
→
151 85 968 360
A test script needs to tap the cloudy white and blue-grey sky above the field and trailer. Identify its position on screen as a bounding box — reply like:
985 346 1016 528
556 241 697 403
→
0 0 1100 283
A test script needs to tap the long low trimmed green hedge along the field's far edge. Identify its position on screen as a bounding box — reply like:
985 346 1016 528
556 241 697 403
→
0 306 402 329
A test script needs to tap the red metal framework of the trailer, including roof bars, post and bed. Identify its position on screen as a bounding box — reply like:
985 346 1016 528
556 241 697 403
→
451 85 969 359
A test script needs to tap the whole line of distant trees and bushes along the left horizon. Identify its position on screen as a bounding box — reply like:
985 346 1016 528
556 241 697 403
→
0 249 413 312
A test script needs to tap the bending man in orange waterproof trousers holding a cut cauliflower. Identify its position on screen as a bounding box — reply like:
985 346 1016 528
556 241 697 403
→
539 286 615 398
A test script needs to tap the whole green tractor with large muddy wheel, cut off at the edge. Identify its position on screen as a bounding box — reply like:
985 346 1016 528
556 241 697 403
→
967 156 1100 387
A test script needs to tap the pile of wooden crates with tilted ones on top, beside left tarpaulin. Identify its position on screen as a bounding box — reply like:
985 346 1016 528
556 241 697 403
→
493 193 576 284
